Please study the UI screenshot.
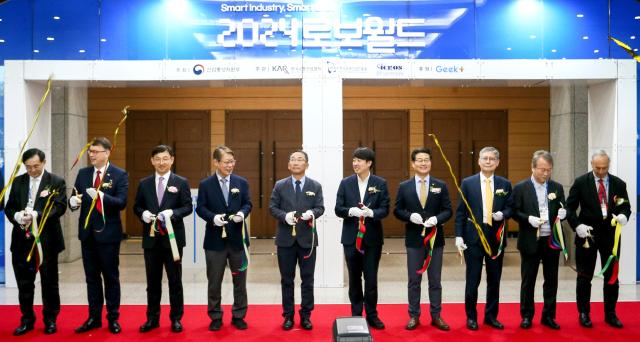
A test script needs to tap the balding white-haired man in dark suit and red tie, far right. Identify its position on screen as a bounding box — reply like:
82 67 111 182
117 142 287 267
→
567 150 631 328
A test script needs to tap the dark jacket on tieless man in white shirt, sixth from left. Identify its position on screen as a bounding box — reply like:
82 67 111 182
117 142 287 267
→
335 174 389 246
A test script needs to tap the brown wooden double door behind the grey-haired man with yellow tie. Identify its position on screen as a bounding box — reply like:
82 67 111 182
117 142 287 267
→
424 110 508 236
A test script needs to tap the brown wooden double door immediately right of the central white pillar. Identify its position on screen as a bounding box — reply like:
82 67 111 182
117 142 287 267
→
343 111 409 236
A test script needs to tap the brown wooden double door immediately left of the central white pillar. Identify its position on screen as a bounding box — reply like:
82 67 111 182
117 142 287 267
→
225 111 304 238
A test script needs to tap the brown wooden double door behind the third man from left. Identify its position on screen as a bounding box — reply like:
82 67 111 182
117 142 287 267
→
125 111 211 236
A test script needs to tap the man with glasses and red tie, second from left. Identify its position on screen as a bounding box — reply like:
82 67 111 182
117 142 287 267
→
69 138 129 334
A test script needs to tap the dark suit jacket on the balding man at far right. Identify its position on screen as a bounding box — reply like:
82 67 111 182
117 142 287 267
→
567 172 631 244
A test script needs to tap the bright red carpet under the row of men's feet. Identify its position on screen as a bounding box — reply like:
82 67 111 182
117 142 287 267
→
0 302 640 342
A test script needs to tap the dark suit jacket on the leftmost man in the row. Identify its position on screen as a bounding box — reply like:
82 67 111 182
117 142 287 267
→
5 170 67 254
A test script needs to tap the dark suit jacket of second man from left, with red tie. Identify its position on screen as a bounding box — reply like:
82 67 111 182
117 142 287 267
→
69 163 129 243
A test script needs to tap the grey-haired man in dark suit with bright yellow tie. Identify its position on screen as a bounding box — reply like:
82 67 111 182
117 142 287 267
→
455 147 513 330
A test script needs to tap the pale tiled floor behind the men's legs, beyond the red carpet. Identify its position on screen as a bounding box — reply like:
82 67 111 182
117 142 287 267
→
0 239 640 304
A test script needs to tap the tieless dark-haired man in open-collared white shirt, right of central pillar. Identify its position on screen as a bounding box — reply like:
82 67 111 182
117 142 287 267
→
335 147 389 329
